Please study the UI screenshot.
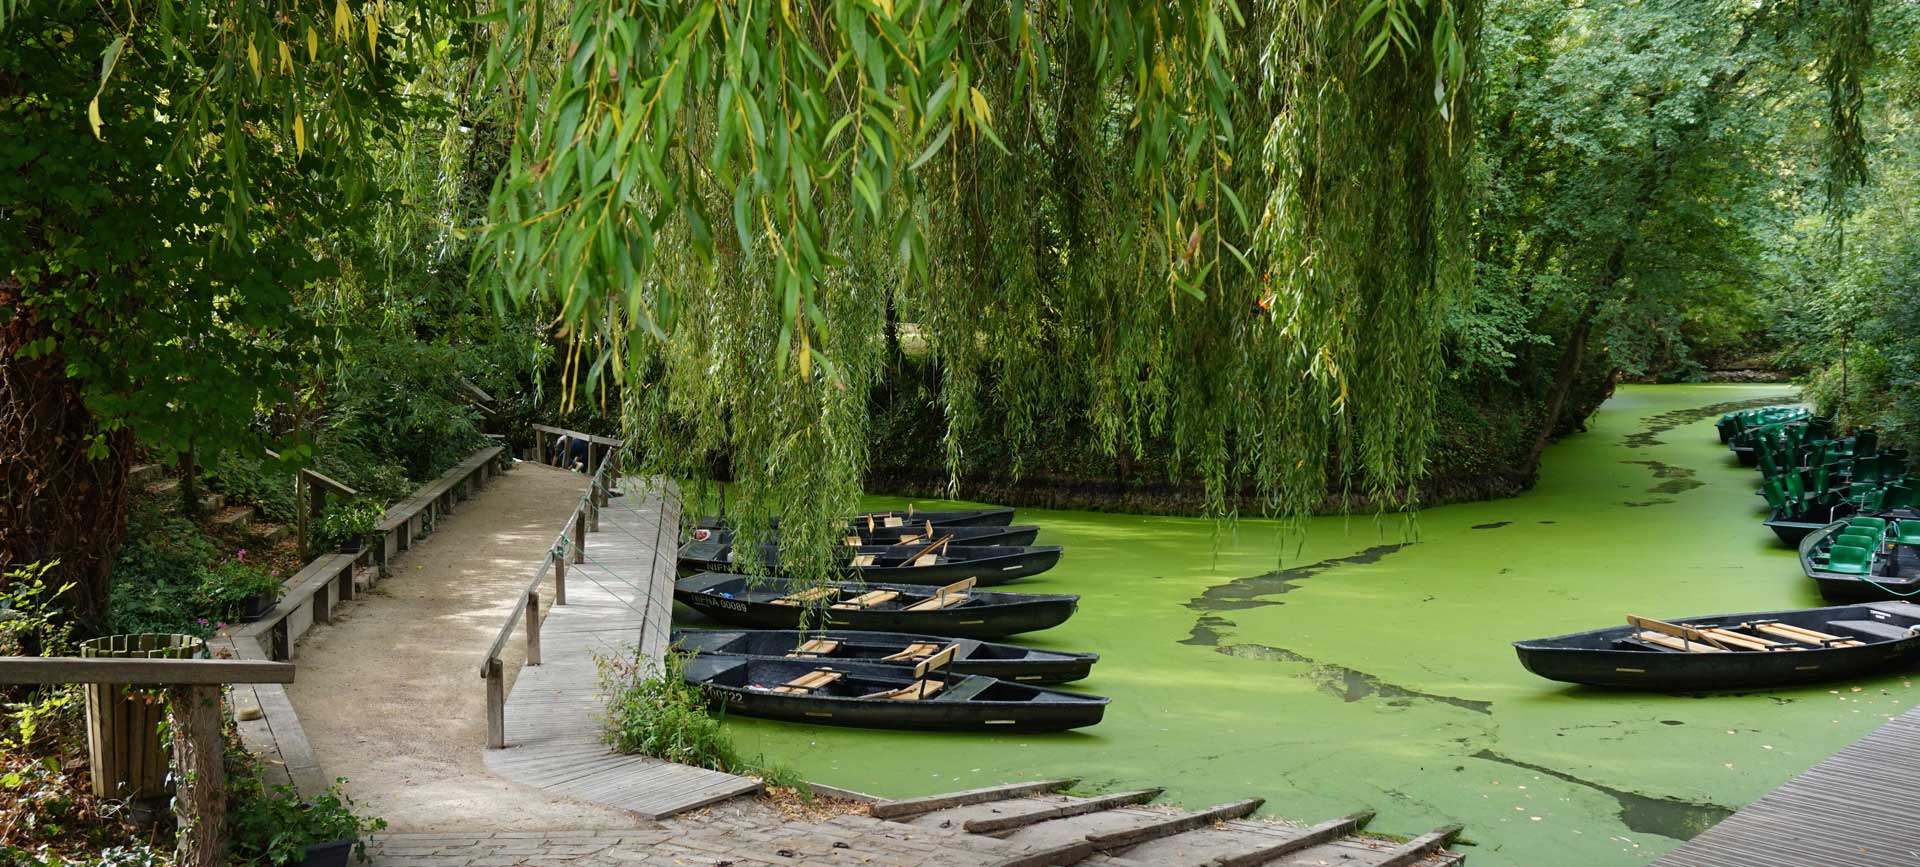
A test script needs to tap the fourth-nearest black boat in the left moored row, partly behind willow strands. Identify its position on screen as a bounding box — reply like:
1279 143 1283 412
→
680 539 1060 587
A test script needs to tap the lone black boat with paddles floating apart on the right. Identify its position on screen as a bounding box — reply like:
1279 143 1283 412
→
1513 602 1920 692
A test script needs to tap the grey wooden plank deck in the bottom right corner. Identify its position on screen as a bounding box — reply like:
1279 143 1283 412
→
1653 708 1920 867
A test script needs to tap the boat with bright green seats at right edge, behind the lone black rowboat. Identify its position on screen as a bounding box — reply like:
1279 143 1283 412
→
1799 506 1920 602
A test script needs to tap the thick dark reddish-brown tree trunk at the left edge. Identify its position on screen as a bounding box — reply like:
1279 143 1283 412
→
0 278 132 629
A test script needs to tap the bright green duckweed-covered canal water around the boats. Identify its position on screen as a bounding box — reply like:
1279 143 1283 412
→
682 386 1912 867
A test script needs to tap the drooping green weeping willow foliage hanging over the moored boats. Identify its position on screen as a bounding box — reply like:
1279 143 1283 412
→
484 0 1476 579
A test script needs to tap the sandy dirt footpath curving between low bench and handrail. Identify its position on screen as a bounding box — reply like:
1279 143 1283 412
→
288 464 645 831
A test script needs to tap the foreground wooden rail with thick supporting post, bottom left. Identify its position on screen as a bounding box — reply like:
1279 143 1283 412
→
0 656 294 867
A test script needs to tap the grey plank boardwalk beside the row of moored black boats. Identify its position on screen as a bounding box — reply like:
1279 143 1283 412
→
486 478 760 819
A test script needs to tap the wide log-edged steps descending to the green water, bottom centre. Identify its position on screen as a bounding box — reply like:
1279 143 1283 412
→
868 779 1467 867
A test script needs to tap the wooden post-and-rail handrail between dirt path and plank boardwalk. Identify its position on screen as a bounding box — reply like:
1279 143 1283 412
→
480 424 622 750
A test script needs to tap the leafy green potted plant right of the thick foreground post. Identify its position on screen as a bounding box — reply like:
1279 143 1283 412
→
227 779 386 867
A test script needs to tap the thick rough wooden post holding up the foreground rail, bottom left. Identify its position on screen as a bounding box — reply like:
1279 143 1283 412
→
167 685 227 867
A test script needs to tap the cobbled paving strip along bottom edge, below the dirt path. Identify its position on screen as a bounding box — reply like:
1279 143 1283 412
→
369 800 1052 867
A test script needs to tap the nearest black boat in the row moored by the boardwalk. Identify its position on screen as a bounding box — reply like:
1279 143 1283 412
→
684 656 1108 731
